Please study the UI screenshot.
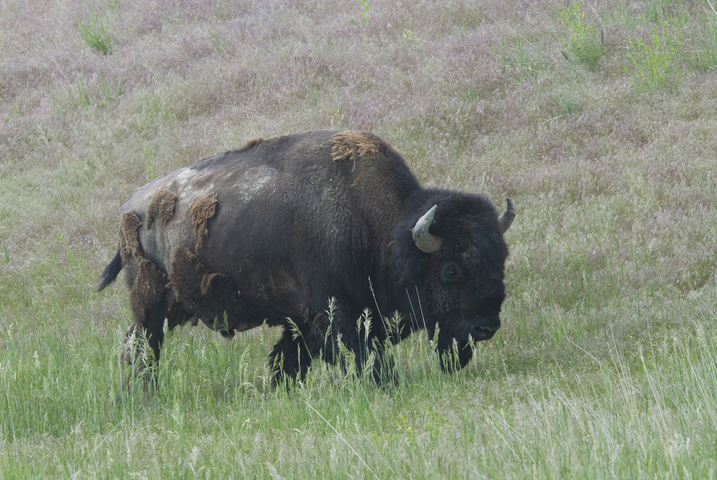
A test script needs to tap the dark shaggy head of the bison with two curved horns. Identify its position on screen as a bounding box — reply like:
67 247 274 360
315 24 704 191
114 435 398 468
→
392 192 515 369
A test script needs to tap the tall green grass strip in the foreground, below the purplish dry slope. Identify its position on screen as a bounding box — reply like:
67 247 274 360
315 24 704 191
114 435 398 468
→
0 266 717 478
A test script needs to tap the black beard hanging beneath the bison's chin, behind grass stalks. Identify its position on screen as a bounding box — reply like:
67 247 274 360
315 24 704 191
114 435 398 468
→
436 314 500 372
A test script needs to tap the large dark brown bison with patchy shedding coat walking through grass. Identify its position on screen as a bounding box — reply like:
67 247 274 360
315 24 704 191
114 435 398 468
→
99 131 515 381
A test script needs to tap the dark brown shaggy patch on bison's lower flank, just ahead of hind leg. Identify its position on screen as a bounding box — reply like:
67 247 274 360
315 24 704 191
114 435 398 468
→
169 247 245 333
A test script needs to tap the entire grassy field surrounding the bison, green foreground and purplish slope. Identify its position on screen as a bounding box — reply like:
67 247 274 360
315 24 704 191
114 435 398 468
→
0 0 717 479
